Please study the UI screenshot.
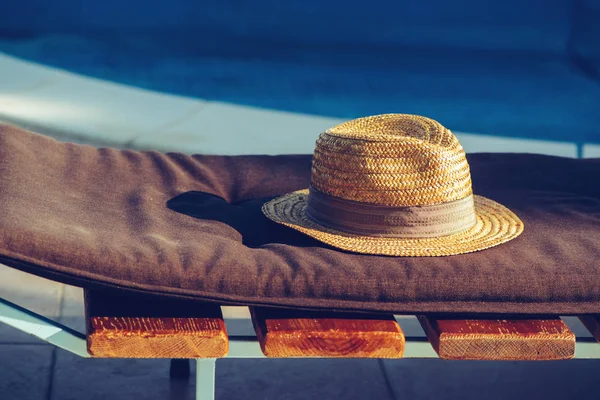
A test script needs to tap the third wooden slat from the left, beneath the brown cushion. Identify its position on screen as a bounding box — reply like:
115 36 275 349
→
419 316 575 360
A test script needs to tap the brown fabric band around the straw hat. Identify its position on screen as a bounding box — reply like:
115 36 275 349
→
306 187 477 238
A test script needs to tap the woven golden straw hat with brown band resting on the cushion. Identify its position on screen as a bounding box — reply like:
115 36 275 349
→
262 114 523 256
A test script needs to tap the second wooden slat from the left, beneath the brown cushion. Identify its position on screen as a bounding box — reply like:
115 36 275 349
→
250 308 405 358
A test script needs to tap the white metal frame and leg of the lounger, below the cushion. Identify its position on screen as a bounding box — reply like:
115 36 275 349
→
0 297 600 400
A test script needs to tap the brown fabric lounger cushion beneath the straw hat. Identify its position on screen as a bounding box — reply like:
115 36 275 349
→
0 126 600 314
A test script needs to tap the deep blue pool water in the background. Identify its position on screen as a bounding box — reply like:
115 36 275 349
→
0 0 600 144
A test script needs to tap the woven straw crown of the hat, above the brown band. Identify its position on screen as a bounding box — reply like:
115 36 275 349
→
311 114 472 206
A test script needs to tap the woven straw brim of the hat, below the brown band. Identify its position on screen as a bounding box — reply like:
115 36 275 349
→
262 189 523 257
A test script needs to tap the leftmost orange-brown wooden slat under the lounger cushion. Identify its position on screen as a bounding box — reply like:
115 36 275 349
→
85 290 229 358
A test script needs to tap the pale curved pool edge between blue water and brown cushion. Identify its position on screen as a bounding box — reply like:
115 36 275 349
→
0 53 584 157
